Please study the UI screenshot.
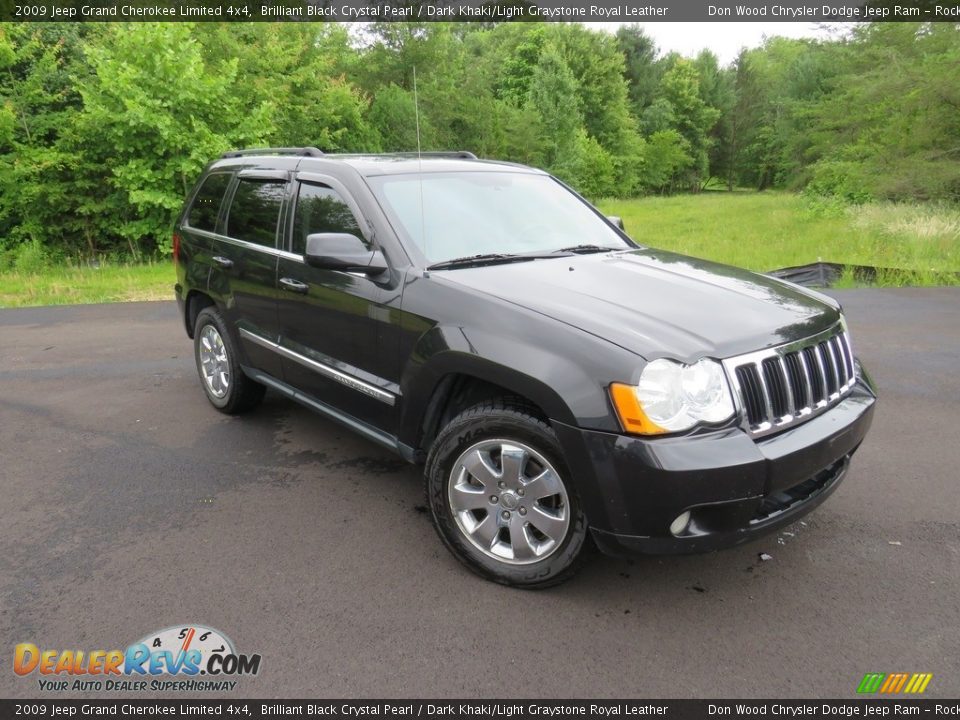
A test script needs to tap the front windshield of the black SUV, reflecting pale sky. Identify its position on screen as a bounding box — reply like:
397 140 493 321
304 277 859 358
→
369 172 630 265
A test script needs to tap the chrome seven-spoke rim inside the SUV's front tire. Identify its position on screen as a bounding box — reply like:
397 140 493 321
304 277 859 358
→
447 440 570 565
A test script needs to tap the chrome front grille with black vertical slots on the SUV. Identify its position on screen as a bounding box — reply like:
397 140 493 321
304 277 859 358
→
724 326 856 435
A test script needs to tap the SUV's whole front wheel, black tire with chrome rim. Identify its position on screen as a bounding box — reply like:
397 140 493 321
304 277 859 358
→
425 401 587 589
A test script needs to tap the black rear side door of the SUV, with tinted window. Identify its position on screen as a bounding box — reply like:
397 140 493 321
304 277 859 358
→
216 170 289 377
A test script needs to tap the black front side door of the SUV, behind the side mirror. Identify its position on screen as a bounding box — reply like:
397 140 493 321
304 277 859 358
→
277 173 398 429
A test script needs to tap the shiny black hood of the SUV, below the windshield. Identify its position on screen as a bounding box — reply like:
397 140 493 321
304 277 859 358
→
434 248 840 361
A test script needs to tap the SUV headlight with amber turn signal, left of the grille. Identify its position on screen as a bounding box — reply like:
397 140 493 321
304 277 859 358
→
610 358 734 435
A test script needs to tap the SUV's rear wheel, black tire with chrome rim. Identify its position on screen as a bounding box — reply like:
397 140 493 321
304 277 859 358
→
193 307 267 415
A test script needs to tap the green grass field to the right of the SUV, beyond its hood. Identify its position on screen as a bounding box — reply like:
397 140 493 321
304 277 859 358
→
599 192 960 285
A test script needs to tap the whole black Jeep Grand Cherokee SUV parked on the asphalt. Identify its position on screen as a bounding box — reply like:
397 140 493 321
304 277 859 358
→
173 148 875 587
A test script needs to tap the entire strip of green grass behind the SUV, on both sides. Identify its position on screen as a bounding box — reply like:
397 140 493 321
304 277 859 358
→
0 192 960 307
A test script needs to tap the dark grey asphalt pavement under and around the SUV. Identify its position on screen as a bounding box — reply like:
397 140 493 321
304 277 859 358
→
0 288 960 699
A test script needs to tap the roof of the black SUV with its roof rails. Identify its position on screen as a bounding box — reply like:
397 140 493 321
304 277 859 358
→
216 148 546 177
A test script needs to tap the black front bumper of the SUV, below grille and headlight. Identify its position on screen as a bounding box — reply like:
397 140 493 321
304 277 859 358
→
554 377 876 555
